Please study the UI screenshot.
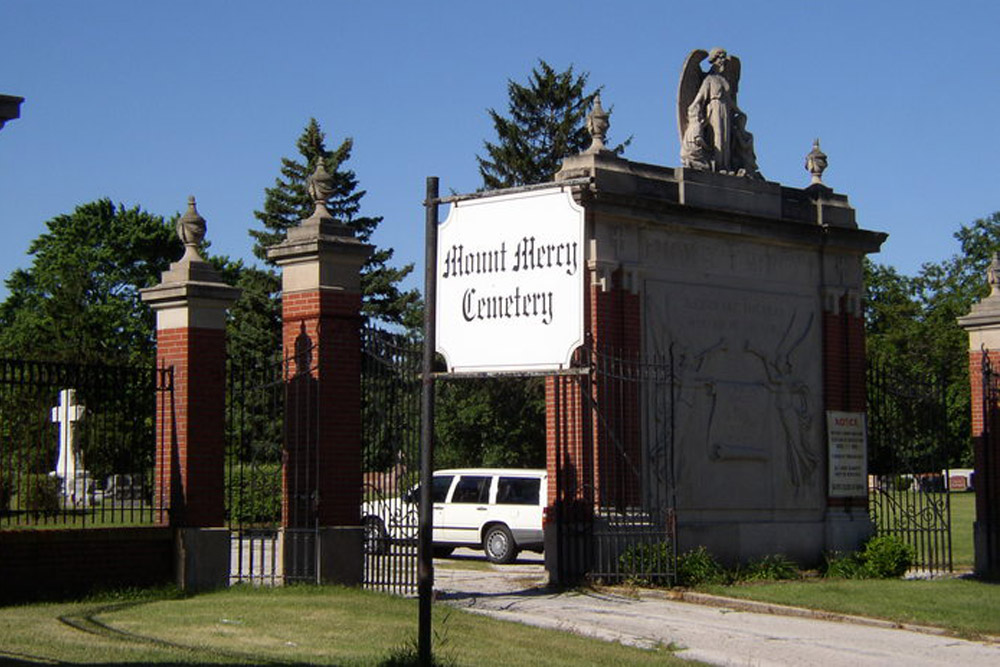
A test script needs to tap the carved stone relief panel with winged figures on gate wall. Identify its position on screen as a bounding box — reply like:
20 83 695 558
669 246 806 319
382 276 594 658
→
645 281 823 510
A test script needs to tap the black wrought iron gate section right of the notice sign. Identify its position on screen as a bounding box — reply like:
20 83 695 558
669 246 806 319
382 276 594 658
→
867 362 956 573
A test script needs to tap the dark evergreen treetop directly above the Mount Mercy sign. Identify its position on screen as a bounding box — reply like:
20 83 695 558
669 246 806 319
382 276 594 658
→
476 60 631 190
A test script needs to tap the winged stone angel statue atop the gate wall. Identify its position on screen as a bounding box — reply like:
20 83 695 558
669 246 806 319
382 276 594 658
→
677 49 763 179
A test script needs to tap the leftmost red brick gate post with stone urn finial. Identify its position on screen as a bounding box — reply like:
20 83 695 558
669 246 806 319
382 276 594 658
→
142 197 240 589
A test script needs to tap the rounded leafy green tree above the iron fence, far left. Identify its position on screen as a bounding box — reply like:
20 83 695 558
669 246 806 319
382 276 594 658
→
0 199 182 364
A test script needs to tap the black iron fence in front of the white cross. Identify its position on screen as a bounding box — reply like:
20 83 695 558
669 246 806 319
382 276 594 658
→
0 359 173 529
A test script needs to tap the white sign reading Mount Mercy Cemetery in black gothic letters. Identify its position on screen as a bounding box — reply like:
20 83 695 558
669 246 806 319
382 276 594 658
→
437 187 586 373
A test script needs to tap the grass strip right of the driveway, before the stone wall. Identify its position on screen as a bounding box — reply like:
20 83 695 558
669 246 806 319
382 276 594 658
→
699 579 1000 637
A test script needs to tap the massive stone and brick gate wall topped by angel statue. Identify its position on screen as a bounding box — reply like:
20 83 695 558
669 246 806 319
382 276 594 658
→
549 49 886 564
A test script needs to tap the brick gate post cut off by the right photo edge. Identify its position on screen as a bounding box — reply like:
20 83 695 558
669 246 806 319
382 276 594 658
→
946 254 1000 579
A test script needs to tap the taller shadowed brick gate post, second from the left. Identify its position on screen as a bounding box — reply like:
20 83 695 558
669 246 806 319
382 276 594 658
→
267 160 372 584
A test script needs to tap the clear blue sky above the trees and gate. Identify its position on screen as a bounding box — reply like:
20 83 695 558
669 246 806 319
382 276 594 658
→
0 0 1000 295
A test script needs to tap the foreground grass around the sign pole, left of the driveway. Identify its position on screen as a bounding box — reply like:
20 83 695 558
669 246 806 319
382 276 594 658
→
0 586 690 666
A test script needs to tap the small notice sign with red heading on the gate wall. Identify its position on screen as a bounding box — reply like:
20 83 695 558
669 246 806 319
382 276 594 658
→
826 410 868 498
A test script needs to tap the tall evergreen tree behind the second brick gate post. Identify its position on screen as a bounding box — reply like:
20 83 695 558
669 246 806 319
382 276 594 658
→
250 118 420 326
